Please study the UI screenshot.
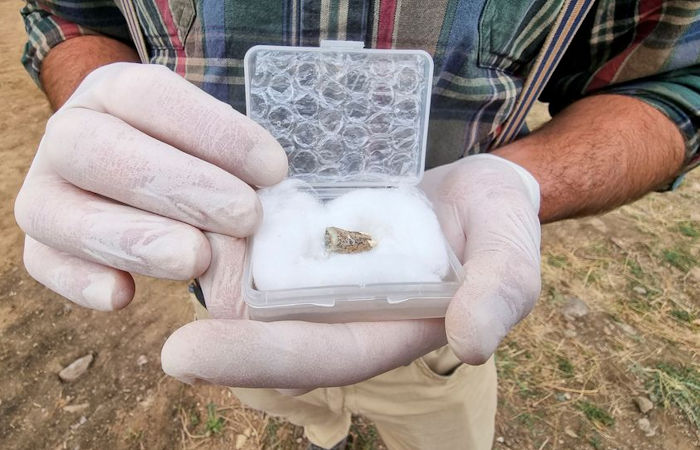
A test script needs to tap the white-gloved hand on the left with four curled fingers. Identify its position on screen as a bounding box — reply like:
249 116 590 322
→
15 63 287 310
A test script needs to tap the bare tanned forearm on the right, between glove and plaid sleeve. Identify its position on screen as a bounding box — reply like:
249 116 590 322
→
495 95 685 223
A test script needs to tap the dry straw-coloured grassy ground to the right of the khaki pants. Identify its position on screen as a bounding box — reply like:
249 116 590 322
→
498 174 700 448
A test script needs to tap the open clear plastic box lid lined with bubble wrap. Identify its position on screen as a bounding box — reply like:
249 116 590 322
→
244 41 433 187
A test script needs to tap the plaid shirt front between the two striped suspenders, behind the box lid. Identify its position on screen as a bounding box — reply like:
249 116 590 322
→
135 0 561 166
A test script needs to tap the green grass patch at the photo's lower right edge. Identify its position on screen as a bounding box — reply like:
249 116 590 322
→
647 363 700 429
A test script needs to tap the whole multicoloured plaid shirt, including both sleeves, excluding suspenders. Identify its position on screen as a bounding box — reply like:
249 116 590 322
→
22 0 700 175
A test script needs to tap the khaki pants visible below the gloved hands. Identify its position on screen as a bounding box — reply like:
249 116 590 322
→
194 300 496 450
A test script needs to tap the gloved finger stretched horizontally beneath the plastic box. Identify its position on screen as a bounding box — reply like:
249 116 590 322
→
161 319 445 389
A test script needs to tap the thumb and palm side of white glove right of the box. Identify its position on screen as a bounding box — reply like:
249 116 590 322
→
421 154 541 364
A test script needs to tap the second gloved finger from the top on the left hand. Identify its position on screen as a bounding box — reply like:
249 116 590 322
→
40 108 262 236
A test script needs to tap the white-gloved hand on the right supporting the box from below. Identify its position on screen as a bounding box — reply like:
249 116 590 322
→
161 155 540 390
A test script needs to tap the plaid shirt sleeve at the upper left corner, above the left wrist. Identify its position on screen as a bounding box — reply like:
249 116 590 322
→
20 0 133 87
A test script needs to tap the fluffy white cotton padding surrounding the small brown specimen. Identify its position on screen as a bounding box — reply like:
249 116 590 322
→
252 180 449 290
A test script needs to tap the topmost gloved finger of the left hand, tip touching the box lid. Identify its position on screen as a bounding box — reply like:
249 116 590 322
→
64 63 287 186
